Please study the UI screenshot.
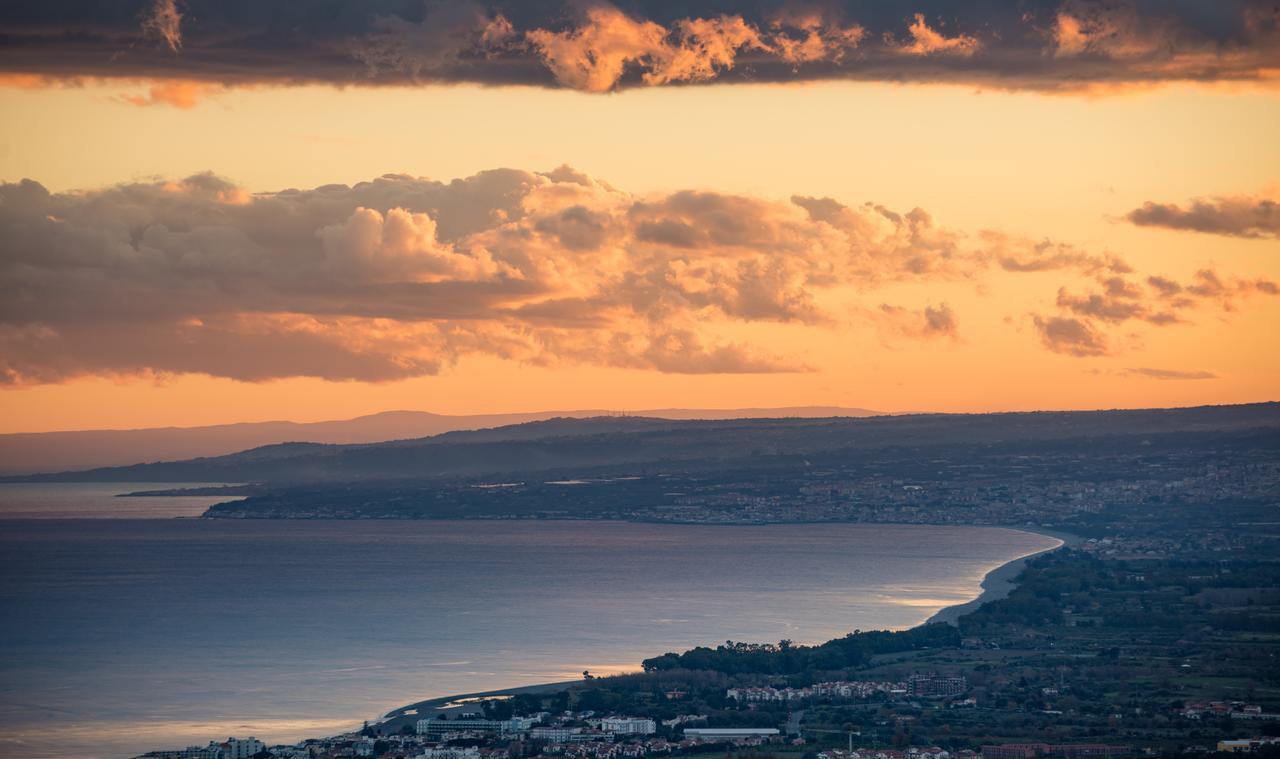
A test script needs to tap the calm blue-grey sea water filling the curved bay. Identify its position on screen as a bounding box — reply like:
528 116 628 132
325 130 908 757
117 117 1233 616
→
0 485 1057 758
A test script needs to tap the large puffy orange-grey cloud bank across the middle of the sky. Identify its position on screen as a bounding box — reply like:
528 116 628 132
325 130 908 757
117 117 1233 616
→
0 166 1277 384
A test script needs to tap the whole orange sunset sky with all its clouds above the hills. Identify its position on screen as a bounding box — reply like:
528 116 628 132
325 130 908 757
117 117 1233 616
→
0 0 1280 431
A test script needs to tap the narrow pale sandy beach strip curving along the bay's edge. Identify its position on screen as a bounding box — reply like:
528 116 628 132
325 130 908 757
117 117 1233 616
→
378 525 1084 726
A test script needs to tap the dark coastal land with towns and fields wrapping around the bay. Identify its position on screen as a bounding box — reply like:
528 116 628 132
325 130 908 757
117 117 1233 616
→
132 412 1280 759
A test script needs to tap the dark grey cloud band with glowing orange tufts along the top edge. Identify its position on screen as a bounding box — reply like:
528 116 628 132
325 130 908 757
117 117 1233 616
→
0 0 1280 94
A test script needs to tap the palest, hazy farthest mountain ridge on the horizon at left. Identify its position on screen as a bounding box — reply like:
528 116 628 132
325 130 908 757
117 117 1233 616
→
0 406 881 475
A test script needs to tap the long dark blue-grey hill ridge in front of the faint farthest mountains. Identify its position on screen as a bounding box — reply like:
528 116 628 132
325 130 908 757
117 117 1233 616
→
7 403 1280 485
